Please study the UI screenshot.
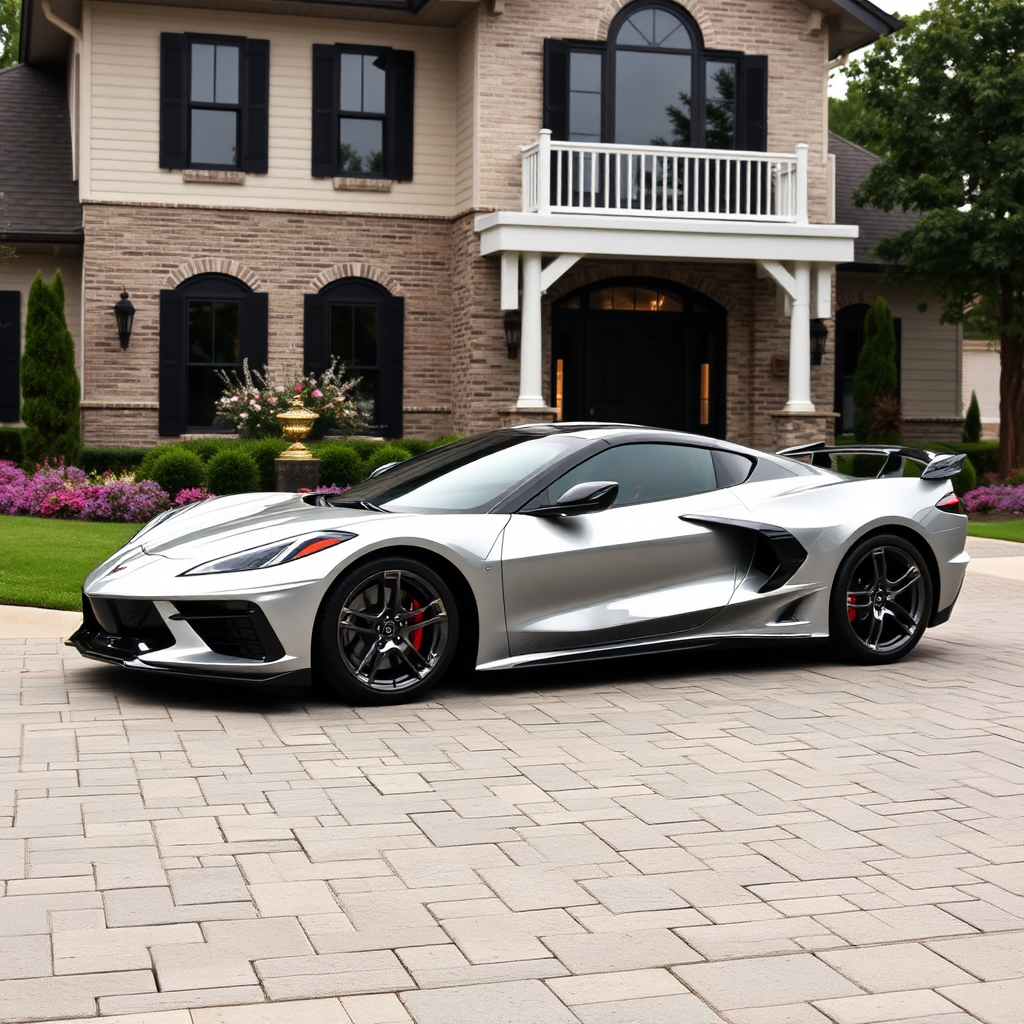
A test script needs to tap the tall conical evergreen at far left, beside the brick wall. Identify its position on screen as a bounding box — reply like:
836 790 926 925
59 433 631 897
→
22 270 82 465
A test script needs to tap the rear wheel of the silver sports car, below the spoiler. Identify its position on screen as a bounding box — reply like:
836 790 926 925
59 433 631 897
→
828 534 932 665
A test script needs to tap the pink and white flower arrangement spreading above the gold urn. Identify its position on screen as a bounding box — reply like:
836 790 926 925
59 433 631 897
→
216 359 361 437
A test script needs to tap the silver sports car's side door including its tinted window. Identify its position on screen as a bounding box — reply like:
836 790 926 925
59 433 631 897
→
502 443 749 657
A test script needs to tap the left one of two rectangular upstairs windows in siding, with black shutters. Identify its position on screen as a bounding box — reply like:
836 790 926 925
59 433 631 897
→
160 33 270 174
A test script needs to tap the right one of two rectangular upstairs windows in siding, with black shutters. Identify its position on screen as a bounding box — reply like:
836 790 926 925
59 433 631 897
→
312 45 414 181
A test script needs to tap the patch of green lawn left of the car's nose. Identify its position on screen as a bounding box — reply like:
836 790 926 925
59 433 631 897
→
0 515 141 611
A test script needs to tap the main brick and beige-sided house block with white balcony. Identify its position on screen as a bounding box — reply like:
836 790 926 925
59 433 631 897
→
0 0 901 446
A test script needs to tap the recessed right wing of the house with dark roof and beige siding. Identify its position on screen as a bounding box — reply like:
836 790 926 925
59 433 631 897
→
828 132 962 444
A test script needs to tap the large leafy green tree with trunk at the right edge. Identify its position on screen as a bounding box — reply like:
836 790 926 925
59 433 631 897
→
854 0 1024 476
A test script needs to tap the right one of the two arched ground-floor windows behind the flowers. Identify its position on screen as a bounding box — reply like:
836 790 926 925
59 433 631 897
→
304 278 404 437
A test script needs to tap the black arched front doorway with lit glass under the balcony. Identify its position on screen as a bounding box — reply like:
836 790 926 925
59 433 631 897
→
551 278 726 437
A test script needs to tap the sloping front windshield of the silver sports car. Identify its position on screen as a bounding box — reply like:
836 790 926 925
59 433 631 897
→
327 431 590 512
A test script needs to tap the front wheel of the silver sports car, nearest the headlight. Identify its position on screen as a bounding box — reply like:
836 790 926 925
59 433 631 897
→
313 557 459 705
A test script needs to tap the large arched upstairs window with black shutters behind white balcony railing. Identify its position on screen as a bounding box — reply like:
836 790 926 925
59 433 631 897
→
545 0 768 151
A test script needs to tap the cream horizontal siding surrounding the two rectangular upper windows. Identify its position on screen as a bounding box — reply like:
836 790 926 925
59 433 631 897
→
82 3 456 216
